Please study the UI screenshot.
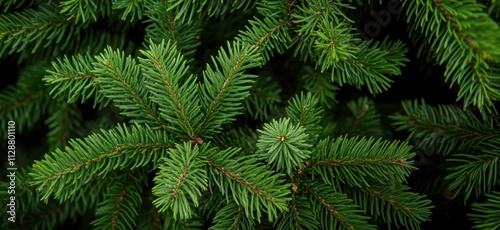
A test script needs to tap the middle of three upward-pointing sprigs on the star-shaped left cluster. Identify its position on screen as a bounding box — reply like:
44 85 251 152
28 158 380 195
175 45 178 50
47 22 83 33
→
139 41 202 140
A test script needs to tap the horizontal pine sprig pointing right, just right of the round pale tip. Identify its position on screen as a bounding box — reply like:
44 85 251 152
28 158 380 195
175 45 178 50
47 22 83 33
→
306 136 414 187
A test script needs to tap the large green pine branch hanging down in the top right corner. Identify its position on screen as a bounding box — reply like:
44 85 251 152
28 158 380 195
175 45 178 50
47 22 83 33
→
403 0 500 112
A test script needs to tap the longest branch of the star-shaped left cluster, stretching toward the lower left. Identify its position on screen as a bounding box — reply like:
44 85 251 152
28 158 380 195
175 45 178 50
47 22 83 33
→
30 125 172 202
